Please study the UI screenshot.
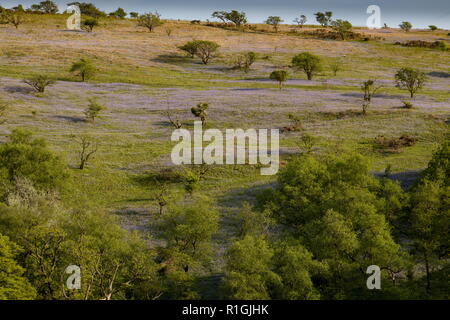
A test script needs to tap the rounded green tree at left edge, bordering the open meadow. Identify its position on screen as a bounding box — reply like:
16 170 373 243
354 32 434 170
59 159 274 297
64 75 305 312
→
0 129 67 196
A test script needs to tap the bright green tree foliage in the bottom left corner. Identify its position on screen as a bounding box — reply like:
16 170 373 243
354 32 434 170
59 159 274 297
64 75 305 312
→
0 234 36 300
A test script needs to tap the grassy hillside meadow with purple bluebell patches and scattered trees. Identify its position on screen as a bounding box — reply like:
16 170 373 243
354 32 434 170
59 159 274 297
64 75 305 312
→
0 11 450 298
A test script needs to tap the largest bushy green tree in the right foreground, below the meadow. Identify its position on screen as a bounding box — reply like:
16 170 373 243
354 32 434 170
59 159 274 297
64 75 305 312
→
260 155 404 298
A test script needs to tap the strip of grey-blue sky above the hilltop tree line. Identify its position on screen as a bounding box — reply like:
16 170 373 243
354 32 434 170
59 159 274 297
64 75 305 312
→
0 0 450 29
